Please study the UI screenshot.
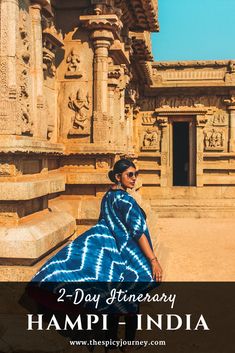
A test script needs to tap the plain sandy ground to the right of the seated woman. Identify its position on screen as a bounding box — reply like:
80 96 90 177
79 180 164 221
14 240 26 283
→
153 218 235 281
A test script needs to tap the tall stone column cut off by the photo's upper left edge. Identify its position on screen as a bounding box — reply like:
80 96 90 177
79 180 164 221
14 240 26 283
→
0 0 19 135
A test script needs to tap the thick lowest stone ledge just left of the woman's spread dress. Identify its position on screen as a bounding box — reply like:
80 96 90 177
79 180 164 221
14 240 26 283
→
0 212 76 264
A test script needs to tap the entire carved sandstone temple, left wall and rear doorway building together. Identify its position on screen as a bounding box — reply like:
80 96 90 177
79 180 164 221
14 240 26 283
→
0 0 235 280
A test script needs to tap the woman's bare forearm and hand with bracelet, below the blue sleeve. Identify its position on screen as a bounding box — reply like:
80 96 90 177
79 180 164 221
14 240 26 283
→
138 234 162 282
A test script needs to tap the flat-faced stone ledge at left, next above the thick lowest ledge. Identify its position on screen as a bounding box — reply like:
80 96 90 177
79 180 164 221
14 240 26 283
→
0 174 65 201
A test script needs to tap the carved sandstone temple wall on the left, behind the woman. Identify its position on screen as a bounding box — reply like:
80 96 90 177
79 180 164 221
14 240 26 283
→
0 0 158 265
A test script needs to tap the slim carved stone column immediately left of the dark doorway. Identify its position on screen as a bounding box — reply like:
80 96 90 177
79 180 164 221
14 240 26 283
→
157 116 170 187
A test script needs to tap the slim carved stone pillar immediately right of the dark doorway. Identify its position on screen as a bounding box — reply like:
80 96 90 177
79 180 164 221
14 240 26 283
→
196 114 208 186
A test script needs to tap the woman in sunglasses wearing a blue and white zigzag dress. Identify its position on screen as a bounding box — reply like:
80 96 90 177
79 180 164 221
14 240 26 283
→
27 159 162 349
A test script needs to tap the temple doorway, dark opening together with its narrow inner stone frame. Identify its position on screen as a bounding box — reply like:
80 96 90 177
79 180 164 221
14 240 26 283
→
172 117 196 186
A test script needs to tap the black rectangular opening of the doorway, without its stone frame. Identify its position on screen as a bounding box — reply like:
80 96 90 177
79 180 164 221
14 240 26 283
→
173 122 189 186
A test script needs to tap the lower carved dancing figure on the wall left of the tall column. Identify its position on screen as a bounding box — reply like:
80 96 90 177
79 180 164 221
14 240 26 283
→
68 89 89 134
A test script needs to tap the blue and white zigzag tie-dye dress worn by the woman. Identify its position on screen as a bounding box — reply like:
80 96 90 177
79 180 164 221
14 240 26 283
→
32 189 153 283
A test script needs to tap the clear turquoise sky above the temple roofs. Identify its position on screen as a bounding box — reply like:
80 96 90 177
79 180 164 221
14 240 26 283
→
152 0 235 61
